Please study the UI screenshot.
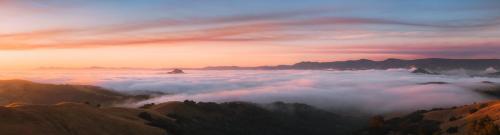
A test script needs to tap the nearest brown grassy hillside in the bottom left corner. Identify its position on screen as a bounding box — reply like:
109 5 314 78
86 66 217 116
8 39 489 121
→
0 103 169 135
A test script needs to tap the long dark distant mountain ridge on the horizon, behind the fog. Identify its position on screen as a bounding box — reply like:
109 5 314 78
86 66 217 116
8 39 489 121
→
202 58 500 70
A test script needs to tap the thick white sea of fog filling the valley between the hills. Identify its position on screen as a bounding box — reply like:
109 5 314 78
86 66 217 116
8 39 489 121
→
0 69 500 113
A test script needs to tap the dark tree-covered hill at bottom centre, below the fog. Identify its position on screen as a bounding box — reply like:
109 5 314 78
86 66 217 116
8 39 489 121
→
141 101 364 135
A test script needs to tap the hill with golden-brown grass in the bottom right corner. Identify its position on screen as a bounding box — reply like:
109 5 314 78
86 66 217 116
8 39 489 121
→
360 101 500 135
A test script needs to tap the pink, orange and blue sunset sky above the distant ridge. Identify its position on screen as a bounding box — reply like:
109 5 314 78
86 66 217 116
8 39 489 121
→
0 0 500 69
